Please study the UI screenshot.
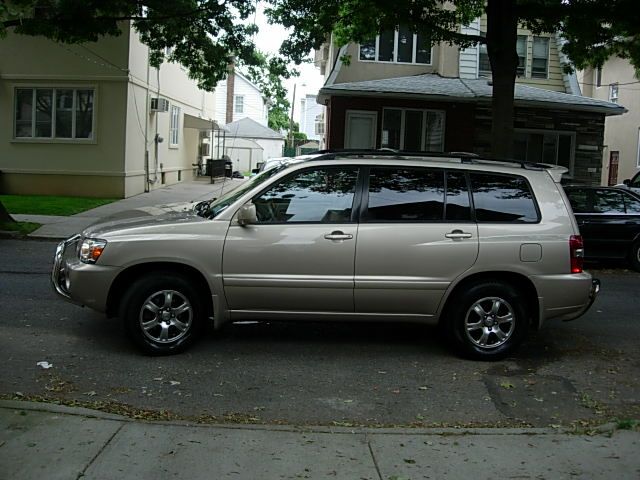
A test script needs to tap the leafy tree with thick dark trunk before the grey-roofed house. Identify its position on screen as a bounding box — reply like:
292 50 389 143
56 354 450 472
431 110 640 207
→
267 0 640 158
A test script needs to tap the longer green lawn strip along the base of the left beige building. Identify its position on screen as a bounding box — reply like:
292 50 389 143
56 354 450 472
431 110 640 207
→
0 195 117 216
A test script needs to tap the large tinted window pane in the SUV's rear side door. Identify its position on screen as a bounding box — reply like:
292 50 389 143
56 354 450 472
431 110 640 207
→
365 168 444 222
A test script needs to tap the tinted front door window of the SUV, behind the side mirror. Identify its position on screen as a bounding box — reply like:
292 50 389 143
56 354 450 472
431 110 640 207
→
253 167 358 223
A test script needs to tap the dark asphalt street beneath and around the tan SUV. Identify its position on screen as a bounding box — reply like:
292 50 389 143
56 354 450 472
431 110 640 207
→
0 240 640 427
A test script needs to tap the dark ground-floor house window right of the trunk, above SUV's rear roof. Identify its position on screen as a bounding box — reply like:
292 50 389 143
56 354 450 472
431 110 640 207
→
513 129 575 175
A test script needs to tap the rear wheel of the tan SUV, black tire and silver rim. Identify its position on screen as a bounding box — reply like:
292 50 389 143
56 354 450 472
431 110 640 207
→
443 281 529 360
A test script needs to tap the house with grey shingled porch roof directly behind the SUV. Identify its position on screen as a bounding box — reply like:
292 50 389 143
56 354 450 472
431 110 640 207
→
316 18 625 183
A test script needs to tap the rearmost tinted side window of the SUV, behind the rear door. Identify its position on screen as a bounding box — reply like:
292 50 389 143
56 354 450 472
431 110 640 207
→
470 173 538 223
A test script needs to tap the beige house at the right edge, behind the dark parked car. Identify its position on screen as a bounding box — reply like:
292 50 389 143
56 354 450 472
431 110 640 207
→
578 57 640 185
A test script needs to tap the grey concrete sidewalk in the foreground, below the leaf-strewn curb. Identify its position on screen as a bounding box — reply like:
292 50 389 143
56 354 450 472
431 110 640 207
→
0 401 640 480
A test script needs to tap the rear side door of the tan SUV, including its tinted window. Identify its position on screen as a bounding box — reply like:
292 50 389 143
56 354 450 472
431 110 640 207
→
354 166 478 316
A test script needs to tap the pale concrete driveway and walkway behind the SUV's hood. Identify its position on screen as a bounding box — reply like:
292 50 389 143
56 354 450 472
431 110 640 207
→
10 178 243 240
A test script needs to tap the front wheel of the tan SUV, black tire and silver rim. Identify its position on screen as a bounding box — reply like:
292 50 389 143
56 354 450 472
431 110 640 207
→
120 272 204 355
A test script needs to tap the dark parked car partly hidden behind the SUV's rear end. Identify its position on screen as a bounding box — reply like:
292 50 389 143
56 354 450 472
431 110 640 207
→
564 185 640 271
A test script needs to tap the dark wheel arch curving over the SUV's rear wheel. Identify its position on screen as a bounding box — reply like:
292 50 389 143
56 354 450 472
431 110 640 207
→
438 271 540 329
